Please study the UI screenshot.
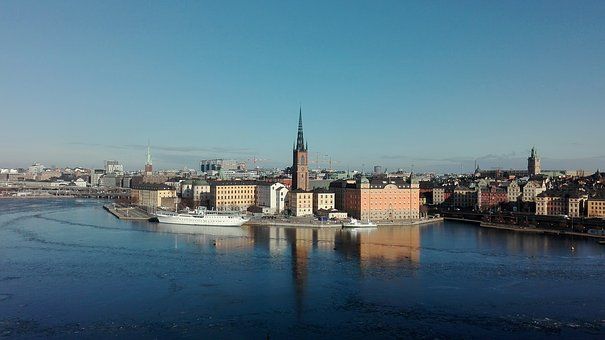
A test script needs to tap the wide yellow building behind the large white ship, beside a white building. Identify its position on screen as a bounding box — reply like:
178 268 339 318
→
209 181 257 210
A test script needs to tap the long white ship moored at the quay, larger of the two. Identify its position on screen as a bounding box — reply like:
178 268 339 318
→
155 207 249 227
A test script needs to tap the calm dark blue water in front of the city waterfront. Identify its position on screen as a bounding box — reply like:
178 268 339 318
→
0 200 605 339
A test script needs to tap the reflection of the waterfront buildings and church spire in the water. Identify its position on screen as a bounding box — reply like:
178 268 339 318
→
145 223 420 316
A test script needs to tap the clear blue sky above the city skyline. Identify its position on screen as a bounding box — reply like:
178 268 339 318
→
0 0 605 172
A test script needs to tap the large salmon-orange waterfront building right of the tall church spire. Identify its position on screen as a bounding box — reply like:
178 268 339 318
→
344 177 420 221
